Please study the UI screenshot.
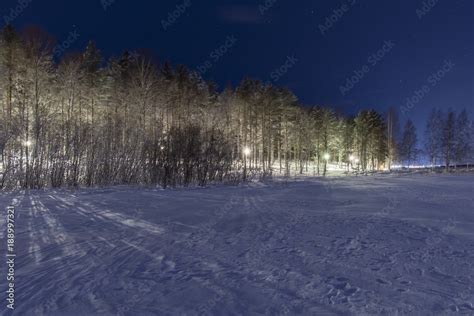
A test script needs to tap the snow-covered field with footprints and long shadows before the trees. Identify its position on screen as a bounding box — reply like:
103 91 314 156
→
0 174 474 315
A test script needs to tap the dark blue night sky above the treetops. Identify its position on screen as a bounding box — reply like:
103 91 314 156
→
0 0 474 132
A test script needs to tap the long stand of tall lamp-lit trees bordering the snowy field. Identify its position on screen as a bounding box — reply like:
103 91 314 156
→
0 26 470 188
